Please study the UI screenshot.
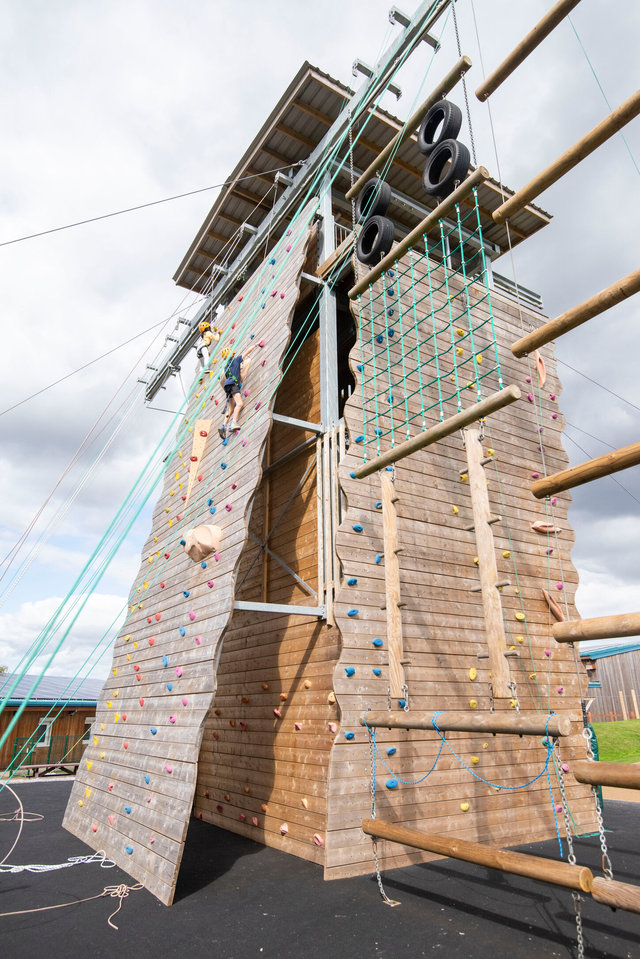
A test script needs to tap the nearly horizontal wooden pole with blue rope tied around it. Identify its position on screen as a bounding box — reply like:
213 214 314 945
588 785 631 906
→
360 709 572 737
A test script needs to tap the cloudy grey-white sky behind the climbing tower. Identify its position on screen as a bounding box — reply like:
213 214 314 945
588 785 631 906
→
0 0 640 675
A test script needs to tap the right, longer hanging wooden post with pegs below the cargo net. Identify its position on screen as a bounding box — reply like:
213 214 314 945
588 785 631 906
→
465 429 513 699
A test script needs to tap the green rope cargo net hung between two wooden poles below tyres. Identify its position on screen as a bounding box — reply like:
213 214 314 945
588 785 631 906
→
354 190 502 462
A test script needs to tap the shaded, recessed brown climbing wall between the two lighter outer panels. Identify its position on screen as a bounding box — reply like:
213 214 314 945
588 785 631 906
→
195 331 339 863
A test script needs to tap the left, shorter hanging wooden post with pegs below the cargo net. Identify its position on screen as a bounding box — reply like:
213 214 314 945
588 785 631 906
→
380 472 405 699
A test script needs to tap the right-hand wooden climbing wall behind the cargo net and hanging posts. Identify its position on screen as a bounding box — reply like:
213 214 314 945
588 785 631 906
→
325 255 594 878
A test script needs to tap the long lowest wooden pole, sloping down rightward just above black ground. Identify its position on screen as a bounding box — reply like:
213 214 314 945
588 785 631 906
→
362 819 593 892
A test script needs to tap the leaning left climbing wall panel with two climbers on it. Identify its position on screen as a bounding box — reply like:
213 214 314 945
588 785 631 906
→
64 201 317 904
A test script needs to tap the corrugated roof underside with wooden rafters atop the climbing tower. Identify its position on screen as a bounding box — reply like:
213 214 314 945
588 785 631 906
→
174 62 551 292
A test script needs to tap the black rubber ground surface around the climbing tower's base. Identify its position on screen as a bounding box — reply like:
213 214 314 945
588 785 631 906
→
0 781 640 959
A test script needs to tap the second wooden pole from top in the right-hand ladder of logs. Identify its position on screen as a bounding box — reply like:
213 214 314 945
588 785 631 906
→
493 90 640 226
